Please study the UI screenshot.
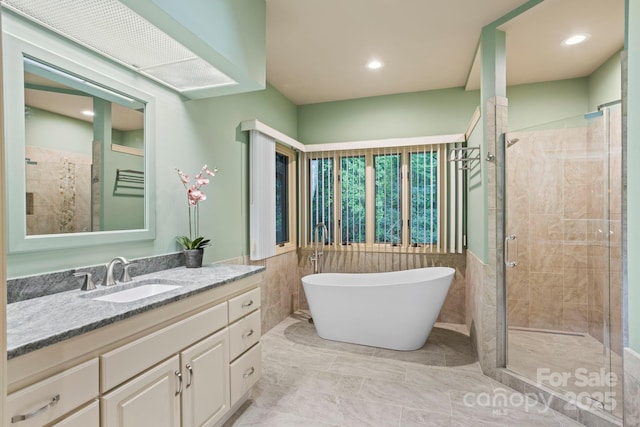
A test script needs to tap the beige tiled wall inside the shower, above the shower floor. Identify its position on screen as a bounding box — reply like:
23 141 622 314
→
507 108 622 348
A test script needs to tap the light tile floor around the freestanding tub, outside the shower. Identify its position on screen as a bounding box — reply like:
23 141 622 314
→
225 313 580 427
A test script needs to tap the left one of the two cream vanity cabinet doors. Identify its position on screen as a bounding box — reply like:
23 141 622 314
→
100 355 183 427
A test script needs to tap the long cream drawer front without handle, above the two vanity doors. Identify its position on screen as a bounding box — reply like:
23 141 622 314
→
100 302 227 392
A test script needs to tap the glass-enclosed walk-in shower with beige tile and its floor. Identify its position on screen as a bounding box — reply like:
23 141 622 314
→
504 105 623 416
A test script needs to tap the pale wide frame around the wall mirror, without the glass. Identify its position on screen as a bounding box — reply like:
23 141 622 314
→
2 34 156 254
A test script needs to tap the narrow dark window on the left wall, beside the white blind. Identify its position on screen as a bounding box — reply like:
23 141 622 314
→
275 144 297 254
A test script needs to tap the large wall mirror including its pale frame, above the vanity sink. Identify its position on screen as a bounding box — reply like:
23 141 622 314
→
4 35 155 252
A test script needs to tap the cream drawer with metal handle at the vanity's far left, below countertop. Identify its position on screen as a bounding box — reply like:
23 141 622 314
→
6 359 98 427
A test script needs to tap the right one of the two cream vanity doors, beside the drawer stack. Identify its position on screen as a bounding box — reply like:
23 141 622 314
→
180 328 230 427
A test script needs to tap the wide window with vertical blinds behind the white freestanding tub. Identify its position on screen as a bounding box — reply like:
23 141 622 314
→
301 144 462 251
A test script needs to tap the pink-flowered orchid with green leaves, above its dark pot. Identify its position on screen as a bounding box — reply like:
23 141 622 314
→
176 165 218 249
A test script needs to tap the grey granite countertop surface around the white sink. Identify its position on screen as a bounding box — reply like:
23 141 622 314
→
7 264 264 359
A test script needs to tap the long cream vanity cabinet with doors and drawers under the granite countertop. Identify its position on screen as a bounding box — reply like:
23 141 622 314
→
6 274 262 427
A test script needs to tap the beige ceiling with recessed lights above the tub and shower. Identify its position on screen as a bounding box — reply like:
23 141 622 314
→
266 0 624 105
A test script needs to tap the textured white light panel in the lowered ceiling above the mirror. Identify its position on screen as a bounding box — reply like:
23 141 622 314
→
2 0 235 92
